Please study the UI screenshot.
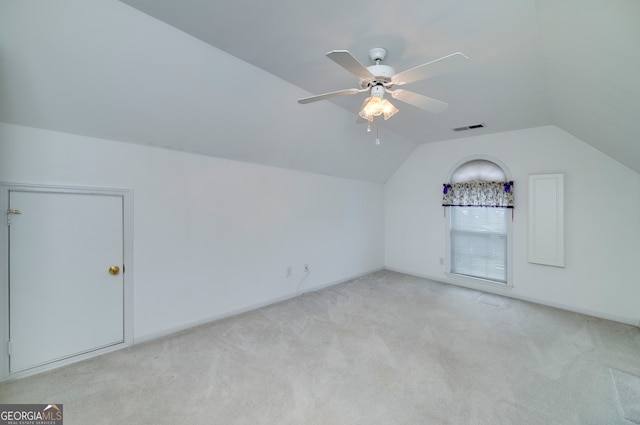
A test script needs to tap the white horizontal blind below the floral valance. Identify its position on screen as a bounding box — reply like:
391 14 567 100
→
449 207 504 283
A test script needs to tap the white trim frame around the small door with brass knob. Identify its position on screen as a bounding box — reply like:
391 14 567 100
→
0 182 134 381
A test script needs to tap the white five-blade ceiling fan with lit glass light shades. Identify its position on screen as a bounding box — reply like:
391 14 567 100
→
298 47 469 122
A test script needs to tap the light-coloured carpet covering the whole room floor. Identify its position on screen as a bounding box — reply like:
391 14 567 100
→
0 271 640 425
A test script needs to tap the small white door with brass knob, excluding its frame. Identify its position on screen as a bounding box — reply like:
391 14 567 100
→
9 190 124 373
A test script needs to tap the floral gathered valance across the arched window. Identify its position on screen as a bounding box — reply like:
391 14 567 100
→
442 181 513 208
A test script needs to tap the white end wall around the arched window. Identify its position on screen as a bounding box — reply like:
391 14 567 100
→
385 126 640 324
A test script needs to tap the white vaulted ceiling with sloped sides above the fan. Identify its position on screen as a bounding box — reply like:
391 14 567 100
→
0 0 640 182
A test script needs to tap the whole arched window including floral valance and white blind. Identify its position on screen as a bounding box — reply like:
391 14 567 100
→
443 159 513 284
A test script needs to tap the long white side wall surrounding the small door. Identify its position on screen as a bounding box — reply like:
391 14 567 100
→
0 124 384 340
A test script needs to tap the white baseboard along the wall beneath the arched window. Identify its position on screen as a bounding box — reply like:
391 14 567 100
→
385 267 640 327
